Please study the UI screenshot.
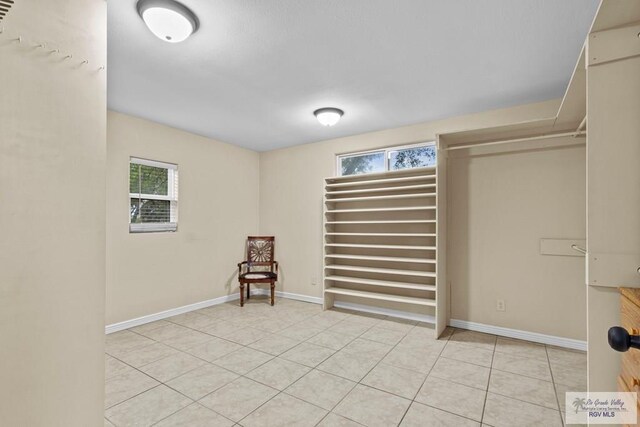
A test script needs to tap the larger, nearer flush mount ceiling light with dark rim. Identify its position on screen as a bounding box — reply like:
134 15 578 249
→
138 0 199 43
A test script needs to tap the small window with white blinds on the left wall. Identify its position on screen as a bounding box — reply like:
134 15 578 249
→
129 157 178 233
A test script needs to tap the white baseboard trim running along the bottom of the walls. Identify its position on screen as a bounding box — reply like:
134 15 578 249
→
105 289 587 351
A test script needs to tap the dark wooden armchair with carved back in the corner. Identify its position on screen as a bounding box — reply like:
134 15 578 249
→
238 236 278 307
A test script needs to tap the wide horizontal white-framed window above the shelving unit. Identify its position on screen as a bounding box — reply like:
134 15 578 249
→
337 142 436 176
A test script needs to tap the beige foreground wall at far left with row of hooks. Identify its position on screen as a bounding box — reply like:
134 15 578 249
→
0 0 106 427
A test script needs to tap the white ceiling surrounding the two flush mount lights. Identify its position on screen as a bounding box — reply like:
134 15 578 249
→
108 0 598 151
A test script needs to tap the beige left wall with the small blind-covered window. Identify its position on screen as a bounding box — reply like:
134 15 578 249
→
106 111 259 324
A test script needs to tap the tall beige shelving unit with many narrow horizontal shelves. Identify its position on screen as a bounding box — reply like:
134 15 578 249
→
323 167 446 335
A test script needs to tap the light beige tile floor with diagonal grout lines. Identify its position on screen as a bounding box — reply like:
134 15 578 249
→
105 297 586 427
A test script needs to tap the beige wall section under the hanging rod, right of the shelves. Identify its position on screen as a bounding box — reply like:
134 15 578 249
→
447 141 587 340
